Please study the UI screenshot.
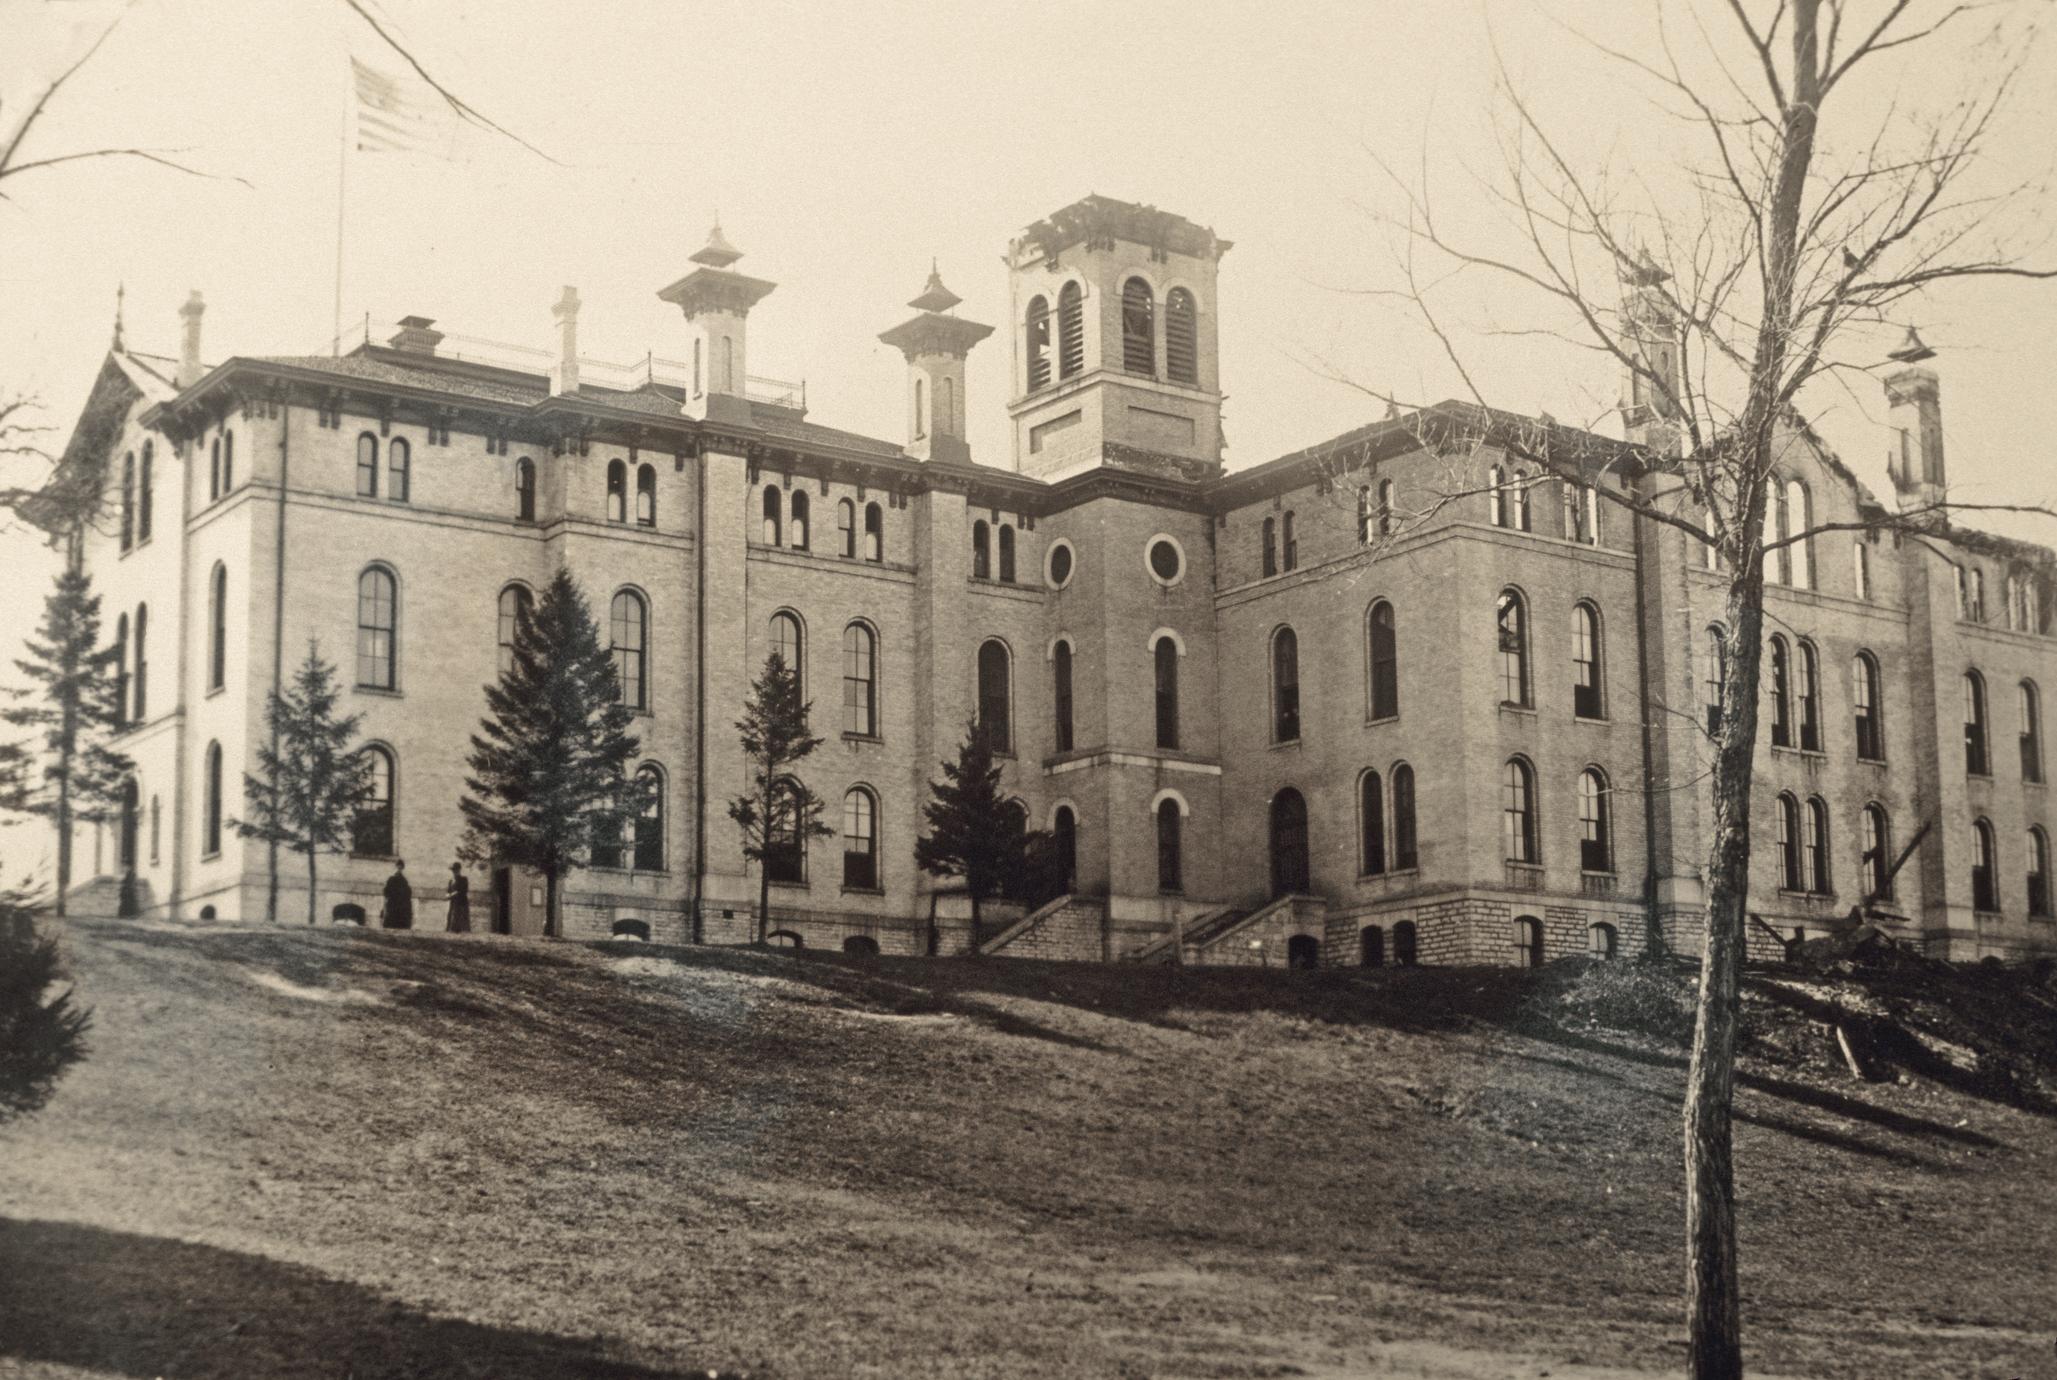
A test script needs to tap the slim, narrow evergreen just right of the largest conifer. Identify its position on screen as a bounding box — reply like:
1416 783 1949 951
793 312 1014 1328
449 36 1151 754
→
728 652 835 944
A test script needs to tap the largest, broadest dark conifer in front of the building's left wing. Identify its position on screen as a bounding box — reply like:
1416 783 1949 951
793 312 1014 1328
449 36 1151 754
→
459 570 644 936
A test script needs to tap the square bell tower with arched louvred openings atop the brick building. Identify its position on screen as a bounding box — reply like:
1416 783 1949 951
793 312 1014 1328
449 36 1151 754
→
1008 195 1230 479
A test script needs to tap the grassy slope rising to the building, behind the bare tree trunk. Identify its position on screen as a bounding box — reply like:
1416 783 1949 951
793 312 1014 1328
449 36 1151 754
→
0 921 2057 1380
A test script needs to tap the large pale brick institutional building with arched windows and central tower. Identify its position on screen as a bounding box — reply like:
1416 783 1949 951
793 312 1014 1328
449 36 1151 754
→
68 197 2057 963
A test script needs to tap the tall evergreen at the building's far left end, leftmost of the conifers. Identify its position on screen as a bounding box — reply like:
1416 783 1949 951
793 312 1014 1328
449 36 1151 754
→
0 559 134 915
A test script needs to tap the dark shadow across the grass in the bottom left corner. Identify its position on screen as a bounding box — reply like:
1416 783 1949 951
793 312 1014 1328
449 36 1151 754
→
0 1220 712 1380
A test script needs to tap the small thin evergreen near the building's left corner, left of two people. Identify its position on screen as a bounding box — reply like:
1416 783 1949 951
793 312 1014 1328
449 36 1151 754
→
228 642 372 925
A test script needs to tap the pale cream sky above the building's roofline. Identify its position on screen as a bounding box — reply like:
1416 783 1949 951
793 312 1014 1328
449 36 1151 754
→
0 0 2057 884
